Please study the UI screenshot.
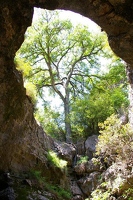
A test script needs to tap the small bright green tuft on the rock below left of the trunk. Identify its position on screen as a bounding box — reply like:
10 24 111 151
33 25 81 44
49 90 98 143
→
47 151 67 169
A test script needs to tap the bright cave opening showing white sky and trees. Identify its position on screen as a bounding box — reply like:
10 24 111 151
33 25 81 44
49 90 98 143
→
16 8 128 142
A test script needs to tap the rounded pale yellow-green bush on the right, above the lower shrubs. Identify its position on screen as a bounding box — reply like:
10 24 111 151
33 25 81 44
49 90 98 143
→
96 115 133 161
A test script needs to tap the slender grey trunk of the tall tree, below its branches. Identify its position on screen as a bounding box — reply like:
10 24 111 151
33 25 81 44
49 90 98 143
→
64 89 72 143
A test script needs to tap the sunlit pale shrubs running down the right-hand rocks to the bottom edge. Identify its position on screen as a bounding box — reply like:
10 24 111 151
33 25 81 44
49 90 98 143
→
90 114 133 200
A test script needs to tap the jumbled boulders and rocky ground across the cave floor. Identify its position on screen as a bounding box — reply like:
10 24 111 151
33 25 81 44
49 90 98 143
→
0 135 133 200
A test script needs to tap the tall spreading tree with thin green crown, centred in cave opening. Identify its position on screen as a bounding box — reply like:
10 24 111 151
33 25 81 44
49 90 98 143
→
19 11 111 142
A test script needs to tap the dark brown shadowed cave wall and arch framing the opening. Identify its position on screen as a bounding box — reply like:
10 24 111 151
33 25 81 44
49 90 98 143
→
0 0 133 170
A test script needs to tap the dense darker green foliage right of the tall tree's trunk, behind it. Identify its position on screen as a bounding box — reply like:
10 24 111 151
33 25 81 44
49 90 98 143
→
71 60 128 141
